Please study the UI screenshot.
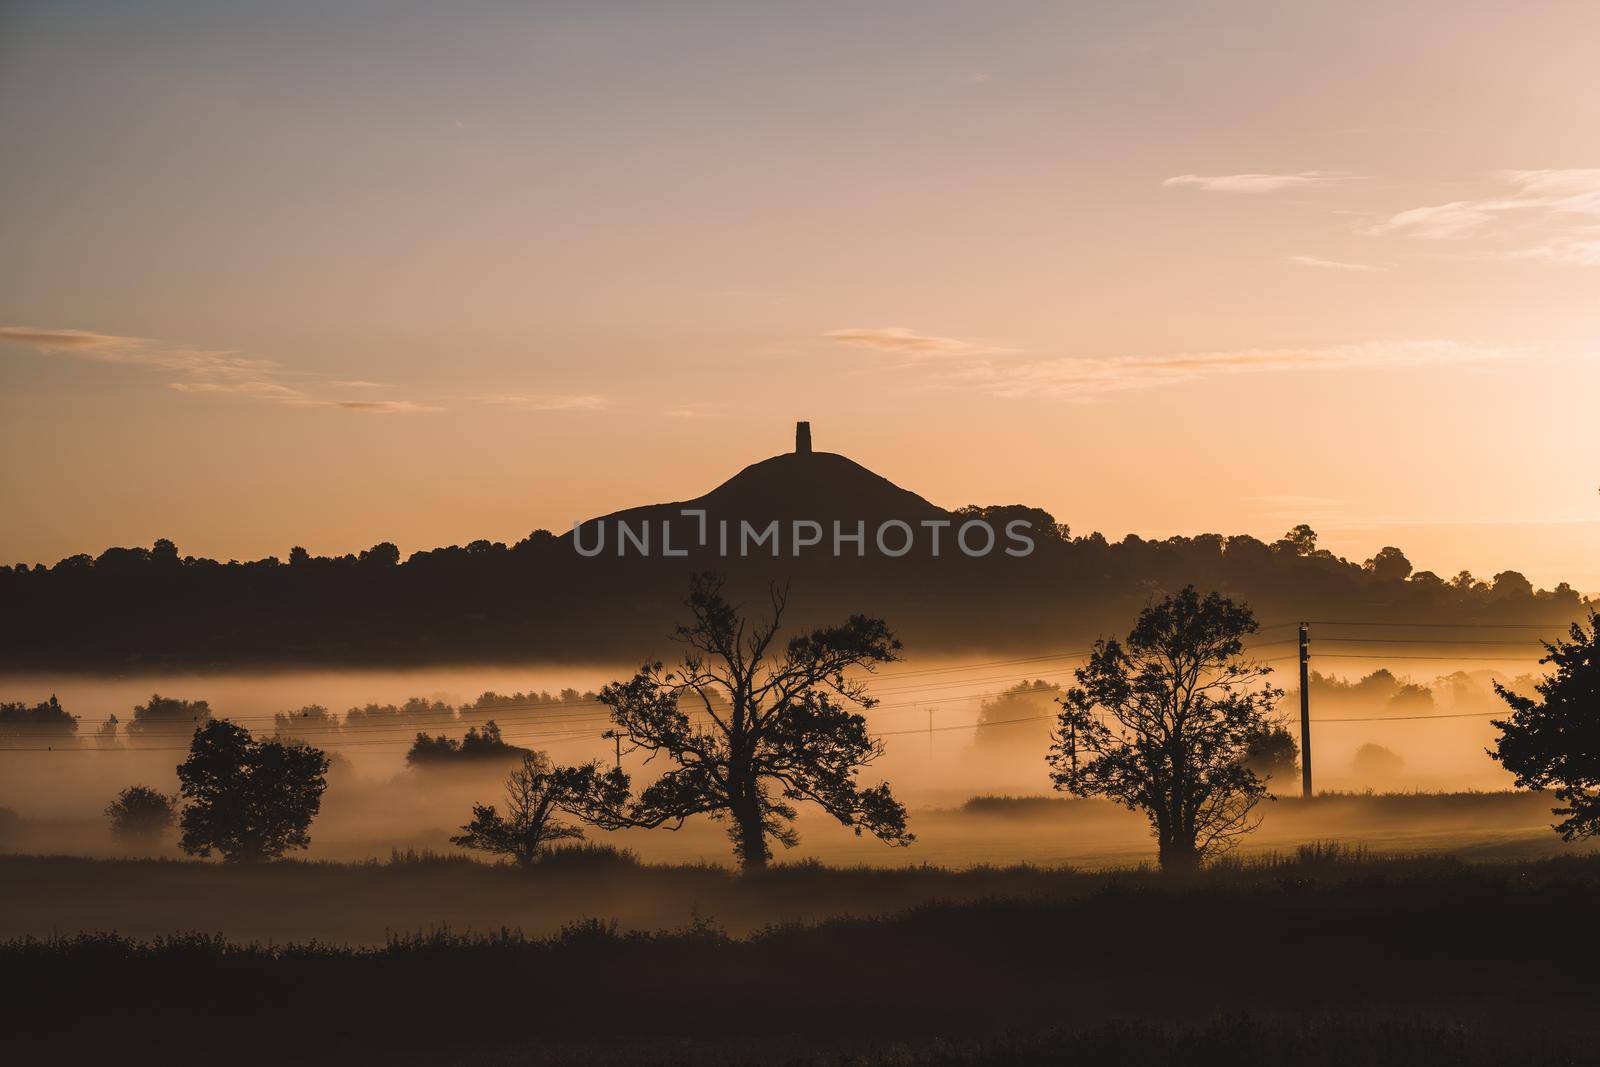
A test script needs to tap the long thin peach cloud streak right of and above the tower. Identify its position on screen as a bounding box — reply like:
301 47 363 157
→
939 341 1515 402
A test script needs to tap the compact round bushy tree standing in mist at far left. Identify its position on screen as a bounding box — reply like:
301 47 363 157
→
178 718 328 864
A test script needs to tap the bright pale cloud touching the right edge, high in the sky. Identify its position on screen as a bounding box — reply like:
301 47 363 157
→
1366 168 1600 251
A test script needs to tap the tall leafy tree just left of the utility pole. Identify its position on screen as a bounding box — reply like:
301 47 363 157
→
1048 585 1283 870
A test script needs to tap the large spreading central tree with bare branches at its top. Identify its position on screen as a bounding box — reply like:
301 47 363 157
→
568 574 912 870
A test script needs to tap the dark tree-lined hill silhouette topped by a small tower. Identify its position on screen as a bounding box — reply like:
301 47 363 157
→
0 430 1584 672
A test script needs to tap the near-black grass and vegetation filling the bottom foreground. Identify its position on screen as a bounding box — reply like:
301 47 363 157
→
0 848 1600 1064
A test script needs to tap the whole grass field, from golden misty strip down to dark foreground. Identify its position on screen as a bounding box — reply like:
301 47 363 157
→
0 793 1600 1067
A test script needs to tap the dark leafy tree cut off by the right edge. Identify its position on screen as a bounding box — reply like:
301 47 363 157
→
1490 611 1600 841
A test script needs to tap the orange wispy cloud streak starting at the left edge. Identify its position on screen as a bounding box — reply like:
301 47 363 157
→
0 326 438 411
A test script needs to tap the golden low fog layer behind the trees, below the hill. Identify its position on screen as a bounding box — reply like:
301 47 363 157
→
0 659 1547 864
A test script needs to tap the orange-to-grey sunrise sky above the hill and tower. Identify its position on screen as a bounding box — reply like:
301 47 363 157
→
0 0 1600 592
